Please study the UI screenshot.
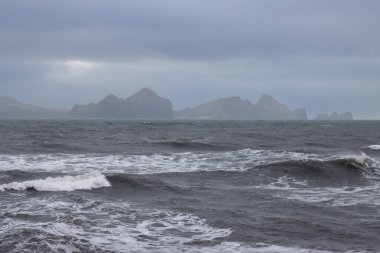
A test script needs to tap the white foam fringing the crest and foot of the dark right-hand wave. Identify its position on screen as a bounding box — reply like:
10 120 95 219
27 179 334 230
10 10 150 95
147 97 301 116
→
251 152 380 206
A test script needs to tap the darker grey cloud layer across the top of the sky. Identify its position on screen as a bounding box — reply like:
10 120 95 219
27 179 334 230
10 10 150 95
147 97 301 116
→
0 0 380 61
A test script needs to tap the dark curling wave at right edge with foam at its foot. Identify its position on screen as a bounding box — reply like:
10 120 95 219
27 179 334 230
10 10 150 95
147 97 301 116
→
252 154 380 207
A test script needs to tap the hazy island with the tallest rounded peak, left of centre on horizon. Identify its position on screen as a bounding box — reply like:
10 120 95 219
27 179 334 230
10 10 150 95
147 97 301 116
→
70 88 173 119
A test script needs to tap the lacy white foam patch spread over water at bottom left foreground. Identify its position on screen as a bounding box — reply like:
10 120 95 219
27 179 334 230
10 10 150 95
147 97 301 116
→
0 197 348 253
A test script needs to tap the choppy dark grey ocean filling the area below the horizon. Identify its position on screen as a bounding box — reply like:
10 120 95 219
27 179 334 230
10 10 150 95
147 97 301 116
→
0 120 380 253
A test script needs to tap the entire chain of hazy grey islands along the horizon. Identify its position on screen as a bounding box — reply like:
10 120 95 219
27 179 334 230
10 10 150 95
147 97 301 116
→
0 88 353 120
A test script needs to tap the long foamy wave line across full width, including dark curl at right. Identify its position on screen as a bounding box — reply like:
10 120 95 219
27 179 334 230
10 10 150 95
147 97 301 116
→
0 149 380 183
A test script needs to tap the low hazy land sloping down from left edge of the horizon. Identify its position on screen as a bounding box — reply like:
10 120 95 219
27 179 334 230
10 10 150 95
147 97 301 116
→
0 97 67 118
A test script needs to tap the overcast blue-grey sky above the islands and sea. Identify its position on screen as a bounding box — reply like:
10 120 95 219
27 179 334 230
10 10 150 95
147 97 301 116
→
0 0 380 119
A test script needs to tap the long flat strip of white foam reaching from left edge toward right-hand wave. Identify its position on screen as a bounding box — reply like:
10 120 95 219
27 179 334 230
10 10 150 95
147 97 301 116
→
0 149 316 174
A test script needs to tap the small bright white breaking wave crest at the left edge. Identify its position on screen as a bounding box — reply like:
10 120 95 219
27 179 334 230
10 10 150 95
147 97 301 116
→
0 172 111 191
